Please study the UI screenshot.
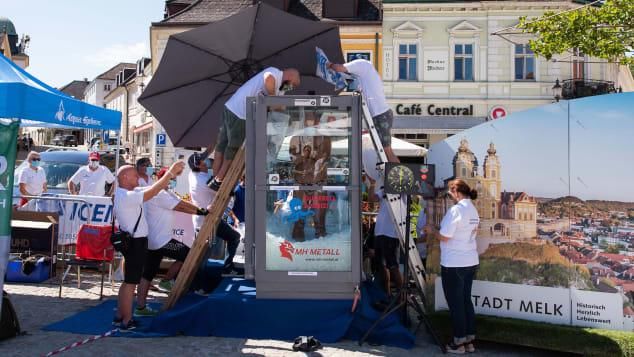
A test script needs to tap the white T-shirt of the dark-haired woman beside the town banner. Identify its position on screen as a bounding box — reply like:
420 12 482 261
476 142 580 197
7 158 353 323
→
440 198 480 268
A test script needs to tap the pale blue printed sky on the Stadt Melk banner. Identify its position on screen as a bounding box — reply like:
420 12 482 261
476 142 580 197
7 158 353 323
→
427 93 634 202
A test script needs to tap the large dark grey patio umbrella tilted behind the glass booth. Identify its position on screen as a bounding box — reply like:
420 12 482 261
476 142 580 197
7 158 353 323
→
139 3 343 146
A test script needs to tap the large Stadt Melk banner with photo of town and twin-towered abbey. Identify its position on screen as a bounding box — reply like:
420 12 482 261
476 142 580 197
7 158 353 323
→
427 93 634 330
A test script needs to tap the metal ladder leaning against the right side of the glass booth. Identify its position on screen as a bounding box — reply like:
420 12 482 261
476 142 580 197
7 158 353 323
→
362 100 426 298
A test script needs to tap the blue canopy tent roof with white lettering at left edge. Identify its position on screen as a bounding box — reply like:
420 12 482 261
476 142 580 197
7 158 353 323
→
0 55 121 130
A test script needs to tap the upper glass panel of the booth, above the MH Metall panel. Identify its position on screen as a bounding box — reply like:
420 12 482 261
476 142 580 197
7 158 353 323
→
265 107 352 185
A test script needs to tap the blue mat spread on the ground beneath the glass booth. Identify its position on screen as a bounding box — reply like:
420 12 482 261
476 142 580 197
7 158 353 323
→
43 278 414 348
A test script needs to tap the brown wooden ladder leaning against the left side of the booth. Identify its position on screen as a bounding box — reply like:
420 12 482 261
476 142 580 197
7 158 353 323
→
163 144 244 311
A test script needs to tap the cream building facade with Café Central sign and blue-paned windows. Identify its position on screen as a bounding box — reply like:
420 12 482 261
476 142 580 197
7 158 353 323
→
382 0 634 147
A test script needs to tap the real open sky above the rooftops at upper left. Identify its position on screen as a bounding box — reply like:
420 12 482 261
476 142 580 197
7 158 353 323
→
0 0 165 88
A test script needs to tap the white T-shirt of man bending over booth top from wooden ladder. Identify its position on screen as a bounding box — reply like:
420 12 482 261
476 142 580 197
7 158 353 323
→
225 67 283 120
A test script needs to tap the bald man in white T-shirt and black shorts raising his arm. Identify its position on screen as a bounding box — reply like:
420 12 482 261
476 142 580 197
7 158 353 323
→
113 161 185 331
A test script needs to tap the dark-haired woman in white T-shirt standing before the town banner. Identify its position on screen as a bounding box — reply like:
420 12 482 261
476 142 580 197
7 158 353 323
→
426 179 480 354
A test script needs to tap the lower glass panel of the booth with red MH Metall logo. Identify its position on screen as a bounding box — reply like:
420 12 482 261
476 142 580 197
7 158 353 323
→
265 190 352 272
